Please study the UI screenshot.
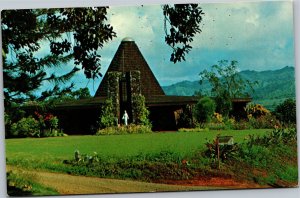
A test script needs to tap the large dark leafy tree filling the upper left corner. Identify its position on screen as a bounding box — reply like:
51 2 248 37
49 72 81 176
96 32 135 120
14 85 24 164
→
1 7 116 102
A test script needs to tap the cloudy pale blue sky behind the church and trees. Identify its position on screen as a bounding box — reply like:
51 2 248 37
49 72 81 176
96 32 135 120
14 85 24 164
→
0 1 295 95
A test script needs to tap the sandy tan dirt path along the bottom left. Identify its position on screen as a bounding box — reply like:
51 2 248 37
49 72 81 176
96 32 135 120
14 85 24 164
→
7 166 220 195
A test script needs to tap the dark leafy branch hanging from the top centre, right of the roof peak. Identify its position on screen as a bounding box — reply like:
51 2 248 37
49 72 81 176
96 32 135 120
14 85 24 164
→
162 4 204 63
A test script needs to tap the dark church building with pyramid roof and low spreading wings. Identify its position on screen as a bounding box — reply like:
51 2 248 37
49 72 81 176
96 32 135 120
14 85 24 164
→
54 38 250 134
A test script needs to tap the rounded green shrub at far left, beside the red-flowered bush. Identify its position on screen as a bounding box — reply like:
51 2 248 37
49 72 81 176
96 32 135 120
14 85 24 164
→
10 117 40 137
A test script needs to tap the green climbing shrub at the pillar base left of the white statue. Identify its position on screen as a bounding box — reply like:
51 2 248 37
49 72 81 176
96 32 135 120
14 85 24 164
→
99 98 118 129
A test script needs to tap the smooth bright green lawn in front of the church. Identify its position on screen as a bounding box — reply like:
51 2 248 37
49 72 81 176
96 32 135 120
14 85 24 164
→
6 129 268 161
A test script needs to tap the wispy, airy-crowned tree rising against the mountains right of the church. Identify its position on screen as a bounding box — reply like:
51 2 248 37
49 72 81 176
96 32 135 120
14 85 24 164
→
199 60 257 116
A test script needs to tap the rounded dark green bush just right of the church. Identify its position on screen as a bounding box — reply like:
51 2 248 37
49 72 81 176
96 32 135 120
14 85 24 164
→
194 97 216 123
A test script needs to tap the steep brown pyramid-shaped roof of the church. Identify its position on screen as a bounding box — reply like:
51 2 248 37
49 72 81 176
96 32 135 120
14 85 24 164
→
95 38 165 98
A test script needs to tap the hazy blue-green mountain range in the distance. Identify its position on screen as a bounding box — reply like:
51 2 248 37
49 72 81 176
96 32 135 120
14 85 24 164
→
162 66 296 110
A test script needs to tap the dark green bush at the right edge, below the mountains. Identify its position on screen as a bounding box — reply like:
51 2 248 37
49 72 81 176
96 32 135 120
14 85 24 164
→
274 99 296 124
